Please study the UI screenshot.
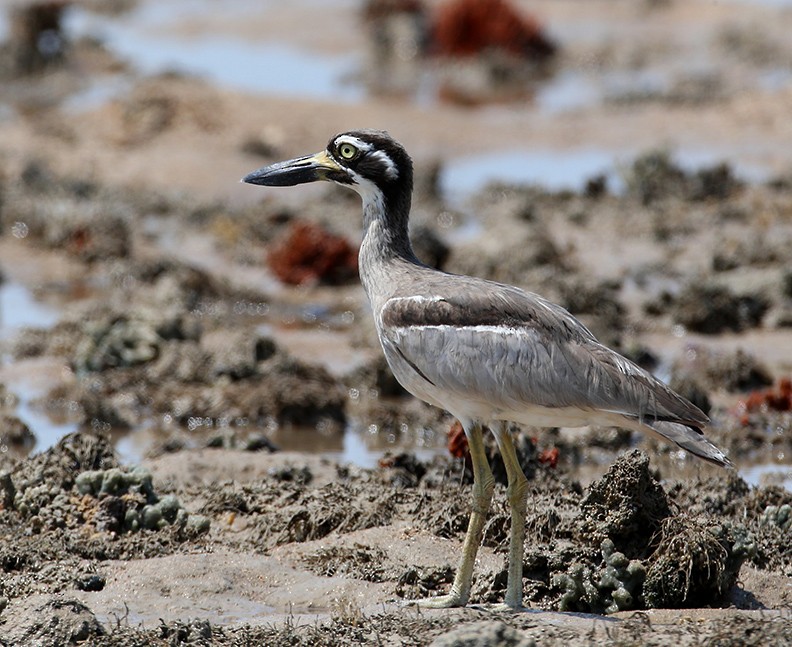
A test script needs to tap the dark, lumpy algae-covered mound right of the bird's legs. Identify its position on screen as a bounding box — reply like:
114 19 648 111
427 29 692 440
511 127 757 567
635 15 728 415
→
551 450 756 613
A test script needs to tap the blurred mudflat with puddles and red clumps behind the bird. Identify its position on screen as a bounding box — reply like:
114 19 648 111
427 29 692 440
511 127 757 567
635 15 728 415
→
0 0 792 487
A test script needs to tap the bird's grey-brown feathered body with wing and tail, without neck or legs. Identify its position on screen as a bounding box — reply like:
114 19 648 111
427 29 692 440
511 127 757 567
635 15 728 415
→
369 261 727 465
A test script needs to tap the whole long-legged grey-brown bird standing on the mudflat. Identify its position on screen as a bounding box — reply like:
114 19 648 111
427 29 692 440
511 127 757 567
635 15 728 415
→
242 129 731 610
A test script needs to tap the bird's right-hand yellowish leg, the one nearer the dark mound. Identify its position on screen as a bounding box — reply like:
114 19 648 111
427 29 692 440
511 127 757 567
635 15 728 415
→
492 422 528 609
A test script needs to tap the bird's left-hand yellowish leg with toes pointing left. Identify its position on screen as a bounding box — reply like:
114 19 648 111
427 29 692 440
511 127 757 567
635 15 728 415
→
418 423 496 608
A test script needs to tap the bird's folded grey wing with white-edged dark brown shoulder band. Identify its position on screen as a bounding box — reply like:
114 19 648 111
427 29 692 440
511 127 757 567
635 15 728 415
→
380 277 708 428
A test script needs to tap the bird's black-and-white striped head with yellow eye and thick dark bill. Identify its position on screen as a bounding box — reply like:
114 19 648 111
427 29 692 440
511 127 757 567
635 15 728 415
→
242 130 412 210
